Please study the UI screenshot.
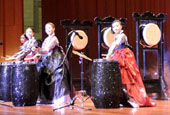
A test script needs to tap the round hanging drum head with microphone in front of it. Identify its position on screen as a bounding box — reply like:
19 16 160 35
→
69 30 88 50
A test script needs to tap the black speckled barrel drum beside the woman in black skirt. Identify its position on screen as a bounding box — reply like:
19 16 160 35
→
12 64 38 106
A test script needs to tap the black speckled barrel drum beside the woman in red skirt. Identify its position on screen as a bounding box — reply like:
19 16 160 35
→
91 59 121 108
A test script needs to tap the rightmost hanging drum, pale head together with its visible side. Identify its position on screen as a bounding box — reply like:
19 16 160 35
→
139 23 161 47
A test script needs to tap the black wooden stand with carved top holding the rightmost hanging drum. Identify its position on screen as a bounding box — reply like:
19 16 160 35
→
133 12 167 99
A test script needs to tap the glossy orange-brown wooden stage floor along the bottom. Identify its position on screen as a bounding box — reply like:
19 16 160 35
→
0 97 170 115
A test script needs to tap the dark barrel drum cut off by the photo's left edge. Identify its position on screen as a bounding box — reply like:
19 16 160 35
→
0 62 13 101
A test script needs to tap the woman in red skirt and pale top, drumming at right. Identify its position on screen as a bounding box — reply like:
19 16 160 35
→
106 20 155 107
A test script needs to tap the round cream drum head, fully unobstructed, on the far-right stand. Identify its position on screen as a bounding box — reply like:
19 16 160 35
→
143 23 161 46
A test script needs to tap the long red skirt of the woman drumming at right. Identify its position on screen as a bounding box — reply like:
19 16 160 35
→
109 48 155 107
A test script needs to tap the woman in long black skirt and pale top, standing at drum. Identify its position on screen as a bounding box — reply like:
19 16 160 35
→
33 22 71 106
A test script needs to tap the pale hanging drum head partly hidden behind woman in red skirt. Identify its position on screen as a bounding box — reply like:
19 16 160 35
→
103 27 115 47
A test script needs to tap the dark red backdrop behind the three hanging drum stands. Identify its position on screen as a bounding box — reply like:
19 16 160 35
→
42 0 170 83
